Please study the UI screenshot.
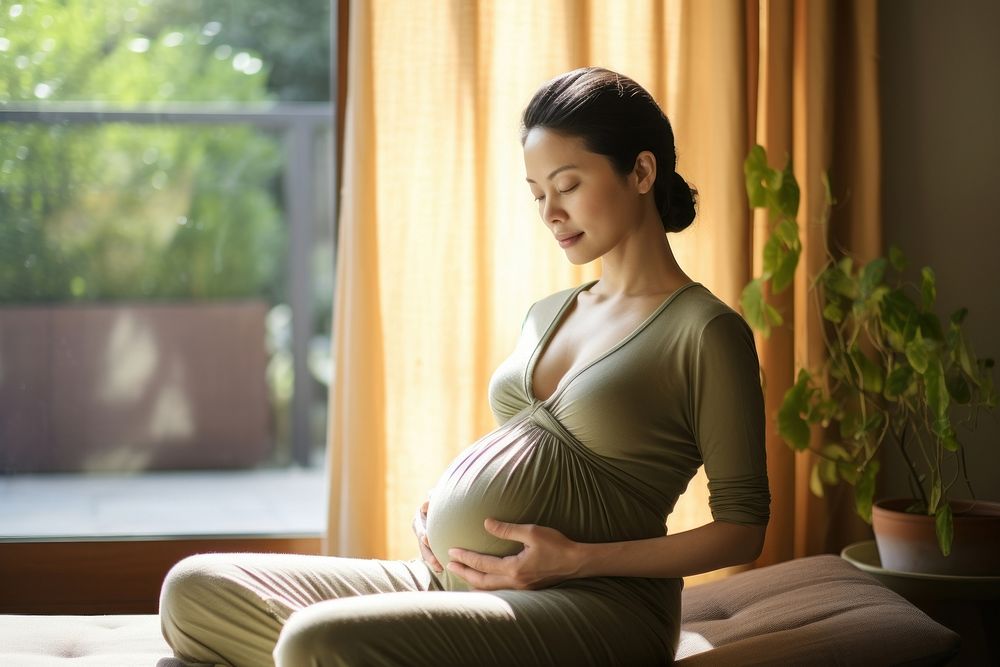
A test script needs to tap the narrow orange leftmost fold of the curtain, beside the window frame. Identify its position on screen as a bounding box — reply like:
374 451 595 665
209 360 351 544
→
323 2 387 554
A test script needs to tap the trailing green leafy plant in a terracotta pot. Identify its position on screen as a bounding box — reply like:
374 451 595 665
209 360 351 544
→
741 146 1000 574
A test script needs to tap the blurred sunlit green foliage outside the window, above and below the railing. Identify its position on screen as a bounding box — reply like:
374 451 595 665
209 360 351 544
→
0 0 329 303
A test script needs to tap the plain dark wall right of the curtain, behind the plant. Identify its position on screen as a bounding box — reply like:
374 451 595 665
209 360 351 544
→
879 0 1000 501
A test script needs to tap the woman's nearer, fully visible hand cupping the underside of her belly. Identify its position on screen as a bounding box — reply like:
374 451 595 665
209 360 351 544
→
448 519 582 591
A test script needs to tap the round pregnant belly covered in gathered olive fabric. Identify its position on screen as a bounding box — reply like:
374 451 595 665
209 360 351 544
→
427 420 663 588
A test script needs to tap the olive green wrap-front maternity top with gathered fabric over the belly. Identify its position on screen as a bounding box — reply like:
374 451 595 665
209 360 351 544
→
427 281 770 590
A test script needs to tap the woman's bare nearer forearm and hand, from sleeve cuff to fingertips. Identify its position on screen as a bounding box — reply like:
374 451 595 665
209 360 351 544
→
448 519 765 590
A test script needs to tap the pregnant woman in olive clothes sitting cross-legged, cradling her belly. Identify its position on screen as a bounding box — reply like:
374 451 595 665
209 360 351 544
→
160 68 770 667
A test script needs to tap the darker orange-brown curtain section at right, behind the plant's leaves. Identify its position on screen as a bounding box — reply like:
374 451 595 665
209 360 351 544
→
748 0 881 564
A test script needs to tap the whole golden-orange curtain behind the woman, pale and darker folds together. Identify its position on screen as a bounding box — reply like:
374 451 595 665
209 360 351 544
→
324 0 880 576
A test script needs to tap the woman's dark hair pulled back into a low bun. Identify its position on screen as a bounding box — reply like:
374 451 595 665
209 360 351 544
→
521 67 698 232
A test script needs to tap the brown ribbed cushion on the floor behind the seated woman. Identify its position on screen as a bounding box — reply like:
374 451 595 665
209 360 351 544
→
677 556 959 667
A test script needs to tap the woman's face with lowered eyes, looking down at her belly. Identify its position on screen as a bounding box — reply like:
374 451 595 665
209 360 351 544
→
524 127 642 264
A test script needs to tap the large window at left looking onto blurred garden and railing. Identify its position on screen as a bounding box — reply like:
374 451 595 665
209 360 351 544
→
0 0 335 536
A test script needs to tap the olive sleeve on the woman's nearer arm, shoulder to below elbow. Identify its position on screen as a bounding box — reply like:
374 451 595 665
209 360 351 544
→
690 311 771 524
